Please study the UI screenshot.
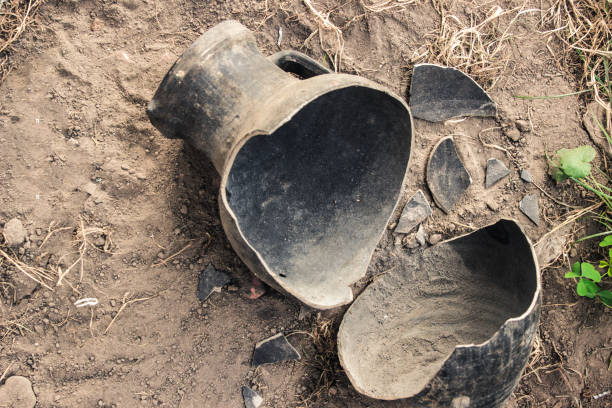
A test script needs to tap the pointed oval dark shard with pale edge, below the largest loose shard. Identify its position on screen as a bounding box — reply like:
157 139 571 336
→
427 136 472 213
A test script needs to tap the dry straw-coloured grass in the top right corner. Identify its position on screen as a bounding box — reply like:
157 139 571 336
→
543 0 612 129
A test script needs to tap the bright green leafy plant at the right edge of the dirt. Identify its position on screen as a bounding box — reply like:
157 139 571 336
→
548 145 612 307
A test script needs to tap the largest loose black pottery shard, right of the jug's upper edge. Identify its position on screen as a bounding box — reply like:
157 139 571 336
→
409 64 497 122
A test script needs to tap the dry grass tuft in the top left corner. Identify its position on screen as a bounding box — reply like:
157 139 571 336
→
0 0 43 83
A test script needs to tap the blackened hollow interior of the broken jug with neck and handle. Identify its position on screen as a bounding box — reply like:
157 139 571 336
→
226 86 411 307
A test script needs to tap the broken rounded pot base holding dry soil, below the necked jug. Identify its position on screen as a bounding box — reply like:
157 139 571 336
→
338 220 541 408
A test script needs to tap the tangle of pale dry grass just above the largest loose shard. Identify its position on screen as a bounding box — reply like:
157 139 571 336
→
411 0 539 89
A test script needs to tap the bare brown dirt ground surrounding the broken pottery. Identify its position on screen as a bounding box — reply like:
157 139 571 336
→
0 0 612 408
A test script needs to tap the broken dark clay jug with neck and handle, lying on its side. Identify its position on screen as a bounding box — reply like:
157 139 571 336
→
147 21 412 309
